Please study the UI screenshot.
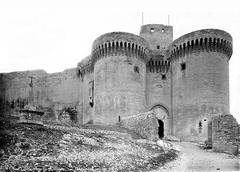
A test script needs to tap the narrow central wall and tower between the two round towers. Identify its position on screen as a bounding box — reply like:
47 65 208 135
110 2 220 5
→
140 24 173 134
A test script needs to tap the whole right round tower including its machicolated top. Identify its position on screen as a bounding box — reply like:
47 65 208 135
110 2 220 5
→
170 29 232 141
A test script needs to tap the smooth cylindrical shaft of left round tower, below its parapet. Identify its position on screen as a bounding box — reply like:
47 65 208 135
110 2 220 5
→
94 56 146 124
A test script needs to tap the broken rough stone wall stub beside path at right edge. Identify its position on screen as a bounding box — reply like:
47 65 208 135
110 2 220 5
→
212 114 240 155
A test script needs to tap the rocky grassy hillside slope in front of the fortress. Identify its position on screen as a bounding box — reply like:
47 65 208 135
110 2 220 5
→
0 121 177 171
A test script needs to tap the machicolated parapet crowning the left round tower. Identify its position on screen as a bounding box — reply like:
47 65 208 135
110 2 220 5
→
92 32 148 64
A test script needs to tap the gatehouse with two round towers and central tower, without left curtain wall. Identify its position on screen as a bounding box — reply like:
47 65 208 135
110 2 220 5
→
78 24 232 140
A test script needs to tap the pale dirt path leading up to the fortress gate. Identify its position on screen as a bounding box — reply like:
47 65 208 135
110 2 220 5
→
157 142 240 172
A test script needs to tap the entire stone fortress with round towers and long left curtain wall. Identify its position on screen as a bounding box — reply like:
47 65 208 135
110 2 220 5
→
0 24 238 150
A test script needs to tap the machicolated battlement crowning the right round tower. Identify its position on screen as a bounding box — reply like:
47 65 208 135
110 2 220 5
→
169 29 232 59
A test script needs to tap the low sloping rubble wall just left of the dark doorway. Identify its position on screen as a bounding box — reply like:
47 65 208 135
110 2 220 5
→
120 111 159 141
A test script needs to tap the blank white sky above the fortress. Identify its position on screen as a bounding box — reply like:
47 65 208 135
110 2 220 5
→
0 0 240 123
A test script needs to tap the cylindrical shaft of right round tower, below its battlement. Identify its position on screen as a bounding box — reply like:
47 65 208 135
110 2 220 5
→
172 51 229 142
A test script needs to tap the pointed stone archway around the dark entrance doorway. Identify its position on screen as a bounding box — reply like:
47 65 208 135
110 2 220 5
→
151 105 170 138
